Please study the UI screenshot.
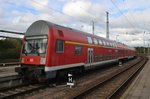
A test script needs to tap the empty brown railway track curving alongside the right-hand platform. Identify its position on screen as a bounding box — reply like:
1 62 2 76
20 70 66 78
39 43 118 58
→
71 57 147 99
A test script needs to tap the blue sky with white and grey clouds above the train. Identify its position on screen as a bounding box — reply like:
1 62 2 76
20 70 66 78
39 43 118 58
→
0 0 150 46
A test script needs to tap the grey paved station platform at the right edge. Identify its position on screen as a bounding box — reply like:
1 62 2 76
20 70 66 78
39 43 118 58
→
121 57 150 99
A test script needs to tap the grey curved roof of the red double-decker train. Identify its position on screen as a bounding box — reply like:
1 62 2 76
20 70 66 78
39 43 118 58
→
25 20 135 50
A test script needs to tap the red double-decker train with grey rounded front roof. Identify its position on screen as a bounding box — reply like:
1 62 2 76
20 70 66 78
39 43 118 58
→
16 20 136 80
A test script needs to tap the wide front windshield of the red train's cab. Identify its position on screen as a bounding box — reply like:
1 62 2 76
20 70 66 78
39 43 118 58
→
23 37 47 55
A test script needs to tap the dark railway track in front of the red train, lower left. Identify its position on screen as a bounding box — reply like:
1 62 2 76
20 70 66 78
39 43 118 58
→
0 76 55 99
